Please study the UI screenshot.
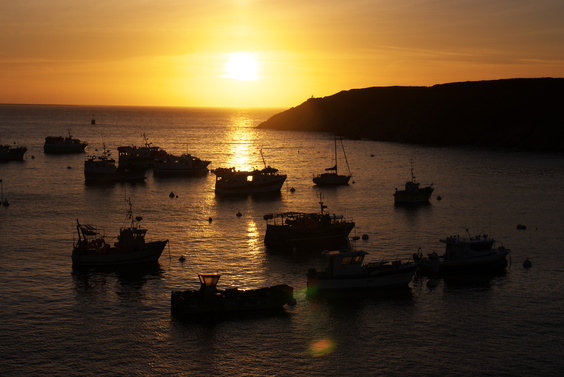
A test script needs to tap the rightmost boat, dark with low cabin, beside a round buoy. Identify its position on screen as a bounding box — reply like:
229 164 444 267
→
413 229 511 274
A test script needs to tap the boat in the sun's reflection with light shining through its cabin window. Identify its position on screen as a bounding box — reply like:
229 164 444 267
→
213 151 287 195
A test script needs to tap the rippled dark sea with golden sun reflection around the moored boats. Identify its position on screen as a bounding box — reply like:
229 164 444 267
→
0 105 564 376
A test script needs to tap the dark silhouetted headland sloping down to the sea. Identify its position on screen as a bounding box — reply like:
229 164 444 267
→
258 78 564 152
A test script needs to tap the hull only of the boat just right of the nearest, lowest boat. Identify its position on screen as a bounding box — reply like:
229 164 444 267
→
307 264 417 293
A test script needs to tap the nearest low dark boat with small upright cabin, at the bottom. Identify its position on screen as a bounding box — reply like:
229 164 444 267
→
170 273 296 319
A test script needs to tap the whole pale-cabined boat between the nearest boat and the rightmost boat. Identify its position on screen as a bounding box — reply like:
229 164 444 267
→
306 249 417 294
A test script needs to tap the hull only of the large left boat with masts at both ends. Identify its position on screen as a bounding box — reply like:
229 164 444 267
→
72 240 168 267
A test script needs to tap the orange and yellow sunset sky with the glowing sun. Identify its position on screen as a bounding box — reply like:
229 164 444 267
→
0 0 564 108
